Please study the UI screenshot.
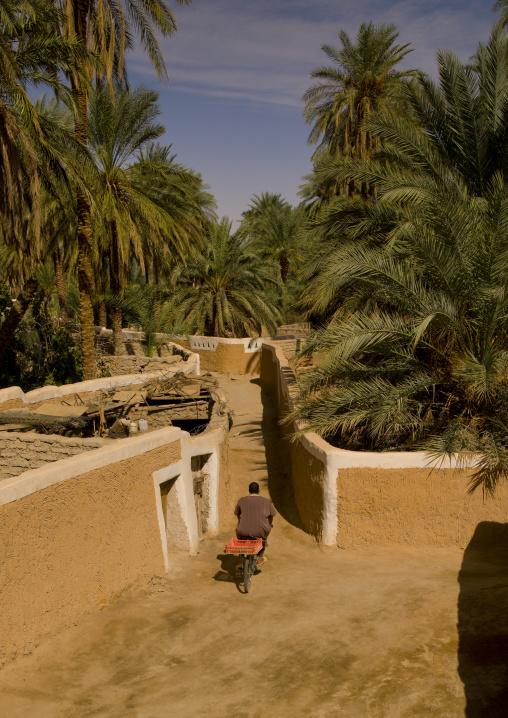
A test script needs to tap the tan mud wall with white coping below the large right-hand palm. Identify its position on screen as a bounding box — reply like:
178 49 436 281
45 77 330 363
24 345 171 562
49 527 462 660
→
261 344 508 548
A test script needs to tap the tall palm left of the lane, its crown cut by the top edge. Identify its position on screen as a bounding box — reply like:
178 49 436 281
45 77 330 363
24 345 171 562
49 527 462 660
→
56 0 190 379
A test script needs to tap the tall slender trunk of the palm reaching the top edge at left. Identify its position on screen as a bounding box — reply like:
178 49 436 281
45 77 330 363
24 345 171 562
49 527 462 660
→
71 0 97 381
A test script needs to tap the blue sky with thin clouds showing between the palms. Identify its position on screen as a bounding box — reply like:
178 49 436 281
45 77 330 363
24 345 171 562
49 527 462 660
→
127 0 494 220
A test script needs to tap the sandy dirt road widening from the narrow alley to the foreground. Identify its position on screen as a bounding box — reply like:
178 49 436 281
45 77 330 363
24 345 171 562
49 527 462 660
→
0 378 500 718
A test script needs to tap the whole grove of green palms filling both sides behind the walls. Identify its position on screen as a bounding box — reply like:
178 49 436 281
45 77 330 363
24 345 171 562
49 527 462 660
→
0 0 508 490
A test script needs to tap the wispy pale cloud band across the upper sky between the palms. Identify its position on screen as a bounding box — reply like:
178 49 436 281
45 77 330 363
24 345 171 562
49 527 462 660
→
130 0 493 107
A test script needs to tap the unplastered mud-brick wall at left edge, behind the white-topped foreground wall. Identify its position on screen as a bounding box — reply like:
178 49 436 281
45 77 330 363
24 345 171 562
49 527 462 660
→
0 431 106 480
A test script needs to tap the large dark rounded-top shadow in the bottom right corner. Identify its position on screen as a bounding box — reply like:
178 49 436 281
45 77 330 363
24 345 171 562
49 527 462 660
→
457 521 508 718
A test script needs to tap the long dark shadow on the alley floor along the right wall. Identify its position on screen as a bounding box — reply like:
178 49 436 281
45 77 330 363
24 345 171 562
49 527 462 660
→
251 379 303 530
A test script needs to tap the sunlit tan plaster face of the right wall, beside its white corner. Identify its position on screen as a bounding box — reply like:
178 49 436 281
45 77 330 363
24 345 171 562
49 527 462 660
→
337 468 508 548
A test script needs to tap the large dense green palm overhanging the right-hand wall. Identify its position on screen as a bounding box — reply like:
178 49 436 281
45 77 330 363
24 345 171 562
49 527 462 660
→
294 28 508 491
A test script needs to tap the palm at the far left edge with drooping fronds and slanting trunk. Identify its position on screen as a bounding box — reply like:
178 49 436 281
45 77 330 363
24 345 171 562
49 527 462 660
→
0 26 86 366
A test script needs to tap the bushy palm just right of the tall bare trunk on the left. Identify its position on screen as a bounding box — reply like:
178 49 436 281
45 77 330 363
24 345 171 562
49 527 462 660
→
88 87 206 355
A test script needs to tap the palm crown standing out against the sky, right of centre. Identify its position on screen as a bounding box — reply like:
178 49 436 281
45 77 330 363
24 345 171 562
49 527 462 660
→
303 22 416 197
